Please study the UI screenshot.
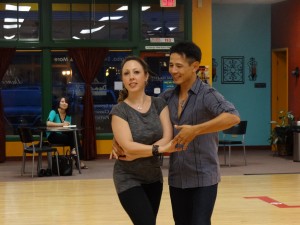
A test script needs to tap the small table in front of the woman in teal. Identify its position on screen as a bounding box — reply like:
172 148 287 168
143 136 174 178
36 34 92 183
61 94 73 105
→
34 126 83 173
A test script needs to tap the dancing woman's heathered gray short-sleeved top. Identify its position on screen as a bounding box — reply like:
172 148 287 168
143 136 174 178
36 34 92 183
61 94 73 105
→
110 97 167 193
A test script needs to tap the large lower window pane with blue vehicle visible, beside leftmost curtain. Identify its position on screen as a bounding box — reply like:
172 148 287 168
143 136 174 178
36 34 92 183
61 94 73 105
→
1 52 42 134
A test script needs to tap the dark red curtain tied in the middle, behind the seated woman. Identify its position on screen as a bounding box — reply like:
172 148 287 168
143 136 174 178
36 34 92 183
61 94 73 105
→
69 48 108 160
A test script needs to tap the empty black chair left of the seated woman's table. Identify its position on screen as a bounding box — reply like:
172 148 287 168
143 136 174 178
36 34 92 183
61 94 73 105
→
18 127 59 177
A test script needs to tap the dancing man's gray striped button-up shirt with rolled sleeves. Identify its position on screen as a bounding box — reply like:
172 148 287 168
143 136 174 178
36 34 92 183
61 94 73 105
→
160 78 239 188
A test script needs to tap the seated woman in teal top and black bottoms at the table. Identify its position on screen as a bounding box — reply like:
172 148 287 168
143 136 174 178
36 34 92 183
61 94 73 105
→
46 97 88 169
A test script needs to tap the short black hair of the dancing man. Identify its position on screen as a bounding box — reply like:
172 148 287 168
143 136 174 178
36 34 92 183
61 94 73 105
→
170 41 202 63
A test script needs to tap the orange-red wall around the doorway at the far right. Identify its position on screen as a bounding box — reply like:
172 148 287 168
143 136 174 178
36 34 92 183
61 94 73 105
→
271 0 300 120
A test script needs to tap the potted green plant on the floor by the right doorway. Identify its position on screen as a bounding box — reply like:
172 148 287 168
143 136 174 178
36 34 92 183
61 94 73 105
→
269 110 295 155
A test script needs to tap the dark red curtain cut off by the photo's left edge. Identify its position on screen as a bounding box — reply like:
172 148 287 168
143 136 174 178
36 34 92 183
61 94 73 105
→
0 48 16 162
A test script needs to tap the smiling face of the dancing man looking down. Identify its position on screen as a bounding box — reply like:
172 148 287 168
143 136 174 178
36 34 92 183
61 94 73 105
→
169 53 198 85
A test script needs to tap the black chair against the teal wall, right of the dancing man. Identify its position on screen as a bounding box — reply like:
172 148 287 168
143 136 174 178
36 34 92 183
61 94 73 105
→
219 121 247 166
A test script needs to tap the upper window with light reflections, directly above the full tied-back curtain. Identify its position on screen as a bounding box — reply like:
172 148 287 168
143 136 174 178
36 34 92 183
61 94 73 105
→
52 1 129 40
